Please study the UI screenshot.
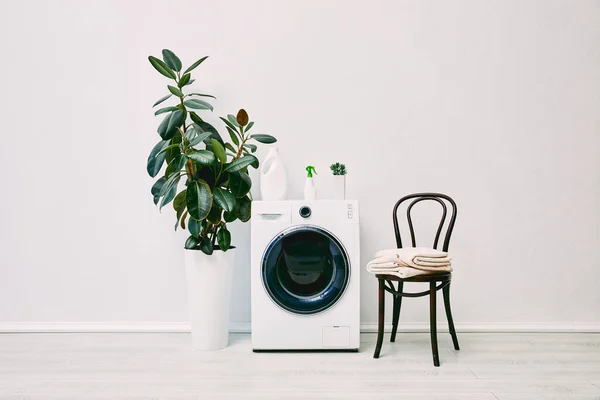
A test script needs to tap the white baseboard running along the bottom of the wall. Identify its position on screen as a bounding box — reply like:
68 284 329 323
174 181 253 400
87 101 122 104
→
0 321 600 333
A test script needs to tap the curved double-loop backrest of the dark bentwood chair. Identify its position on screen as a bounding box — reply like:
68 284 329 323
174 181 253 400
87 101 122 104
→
392 193 457 251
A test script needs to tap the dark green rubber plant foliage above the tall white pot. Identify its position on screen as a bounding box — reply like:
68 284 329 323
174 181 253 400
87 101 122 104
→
147 49 276 255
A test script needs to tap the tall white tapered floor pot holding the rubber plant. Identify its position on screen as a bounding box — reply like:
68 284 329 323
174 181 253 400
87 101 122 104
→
185 249 235 350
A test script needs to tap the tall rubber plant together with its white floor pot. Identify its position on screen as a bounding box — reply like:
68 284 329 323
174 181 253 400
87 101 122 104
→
147 50 276 350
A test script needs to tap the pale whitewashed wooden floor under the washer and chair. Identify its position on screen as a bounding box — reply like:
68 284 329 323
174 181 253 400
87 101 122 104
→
0 333 600 400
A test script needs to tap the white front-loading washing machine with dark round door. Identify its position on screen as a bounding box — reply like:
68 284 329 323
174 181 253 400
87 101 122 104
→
251 200 361 351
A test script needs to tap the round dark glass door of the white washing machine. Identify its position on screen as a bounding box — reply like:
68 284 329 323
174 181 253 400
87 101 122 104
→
262 225 350 314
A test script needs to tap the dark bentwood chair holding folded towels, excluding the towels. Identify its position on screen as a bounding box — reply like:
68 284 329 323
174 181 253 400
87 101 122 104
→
373 193 460 367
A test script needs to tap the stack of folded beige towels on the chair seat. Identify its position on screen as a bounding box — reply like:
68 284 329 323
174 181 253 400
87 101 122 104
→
367 247 452 278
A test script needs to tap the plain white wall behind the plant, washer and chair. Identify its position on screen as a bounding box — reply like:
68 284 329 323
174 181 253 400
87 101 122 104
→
0 0 600 329
